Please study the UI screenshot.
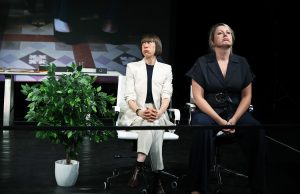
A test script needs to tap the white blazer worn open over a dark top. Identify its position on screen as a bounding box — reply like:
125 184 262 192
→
118 59 173 126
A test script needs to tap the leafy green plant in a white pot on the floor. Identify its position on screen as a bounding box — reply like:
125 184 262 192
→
21 63 116 186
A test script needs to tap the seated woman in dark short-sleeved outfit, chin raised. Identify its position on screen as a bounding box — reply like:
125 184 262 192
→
186 23 266 194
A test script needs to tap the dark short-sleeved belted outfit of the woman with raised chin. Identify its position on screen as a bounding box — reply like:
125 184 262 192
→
186 53 266 194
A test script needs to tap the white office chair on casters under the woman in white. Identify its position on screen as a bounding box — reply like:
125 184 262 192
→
104 75 180 194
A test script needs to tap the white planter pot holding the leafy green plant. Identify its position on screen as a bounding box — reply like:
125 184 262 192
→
55 160 79 187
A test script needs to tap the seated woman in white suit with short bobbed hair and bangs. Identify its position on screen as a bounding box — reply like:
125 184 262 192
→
119 35 173 194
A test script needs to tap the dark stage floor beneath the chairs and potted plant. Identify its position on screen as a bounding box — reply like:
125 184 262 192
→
0 127 300 194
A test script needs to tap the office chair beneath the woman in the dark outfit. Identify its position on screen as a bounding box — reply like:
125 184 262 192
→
186 86 248 193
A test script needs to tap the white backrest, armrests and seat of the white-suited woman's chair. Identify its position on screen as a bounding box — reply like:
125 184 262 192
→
114 75 180 140
